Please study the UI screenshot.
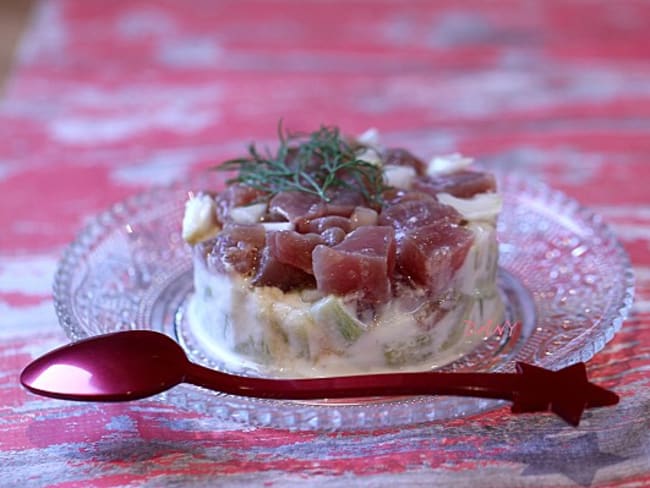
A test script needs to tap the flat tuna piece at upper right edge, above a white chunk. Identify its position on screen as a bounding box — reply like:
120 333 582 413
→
413 171 497 198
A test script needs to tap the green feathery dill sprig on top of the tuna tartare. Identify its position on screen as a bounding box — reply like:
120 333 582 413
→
216 123 387 205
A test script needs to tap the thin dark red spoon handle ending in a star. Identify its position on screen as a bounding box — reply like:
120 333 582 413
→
185 363 619 425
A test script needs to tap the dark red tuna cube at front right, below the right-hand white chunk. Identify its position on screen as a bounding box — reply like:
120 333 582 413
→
397 221 474 294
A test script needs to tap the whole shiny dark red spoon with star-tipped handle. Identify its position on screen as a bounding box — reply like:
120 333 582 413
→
20 330 618 425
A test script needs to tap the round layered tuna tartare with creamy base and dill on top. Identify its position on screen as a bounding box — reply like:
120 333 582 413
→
183 127 504 376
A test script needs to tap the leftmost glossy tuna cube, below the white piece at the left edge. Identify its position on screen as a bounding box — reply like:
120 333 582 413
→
208 224 266 275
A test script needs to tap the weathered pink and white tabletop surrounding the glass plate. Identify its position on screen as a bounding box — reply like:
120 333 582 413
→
0 0 650 488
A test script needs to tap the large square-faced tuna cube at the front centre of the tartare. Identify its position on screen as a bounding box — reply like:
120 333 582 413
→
313 226 395 303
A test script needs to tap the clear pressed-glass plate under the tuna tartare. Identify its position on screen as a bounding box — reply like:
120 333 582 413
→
54 173 634 430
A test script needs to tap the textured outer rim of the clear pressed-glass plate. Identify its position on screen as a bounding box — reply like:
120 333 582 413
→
53 171 634 431
